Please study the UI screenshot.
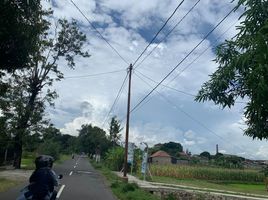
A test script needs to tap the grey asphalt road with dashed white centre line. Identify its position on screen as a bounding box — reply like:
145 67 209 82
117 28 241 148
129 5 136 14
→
0 156 116 200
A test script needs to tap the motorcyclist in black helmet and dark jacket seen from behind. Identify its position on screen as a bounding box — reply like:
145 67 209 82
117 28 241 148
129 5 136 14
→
28 155 59 200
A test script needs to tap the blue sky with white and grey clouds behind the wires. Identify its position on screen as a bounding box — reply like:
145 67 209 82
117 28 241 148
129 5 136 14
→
43 0 268 159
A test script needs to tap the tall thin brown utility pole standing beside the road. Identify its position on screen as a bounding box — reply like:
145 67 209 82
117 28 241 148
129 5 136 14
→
123 64 133 180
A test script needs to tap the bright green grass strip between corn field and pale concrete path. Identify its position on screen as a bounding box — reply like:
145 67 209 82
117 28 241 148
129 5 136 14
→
152 176 268 195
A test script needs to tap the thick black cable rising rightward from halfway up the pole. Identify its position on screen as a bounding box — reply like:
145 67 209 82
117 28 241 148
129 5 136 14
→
131 7 236 112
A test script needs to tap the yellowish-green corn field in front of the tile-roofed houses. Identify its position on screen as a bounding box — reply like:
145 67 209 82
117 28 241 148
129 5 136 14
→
150 165 264 183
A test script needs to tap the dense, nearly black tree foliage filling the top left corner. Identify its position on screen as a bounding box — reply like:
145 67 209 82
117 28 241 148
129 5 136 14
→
0 0 44 72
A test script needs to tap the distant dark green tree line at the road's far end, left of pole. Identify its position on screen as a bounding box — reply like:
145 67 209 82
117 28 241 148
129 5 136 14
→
0 116 122 164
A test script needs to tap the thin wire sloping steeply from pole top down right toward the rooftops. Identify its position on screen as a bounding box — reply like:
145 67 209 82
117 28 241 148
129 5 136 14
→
135 74 249 155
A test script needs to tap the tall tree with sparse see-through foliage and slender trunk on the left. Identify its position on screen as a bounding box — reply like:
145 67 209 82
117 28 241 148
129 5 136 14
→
1 12 89 168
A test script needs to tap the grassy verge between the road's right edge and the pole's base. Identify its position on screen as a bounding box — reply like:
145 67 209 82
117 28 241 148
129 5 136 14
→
90 161 159 200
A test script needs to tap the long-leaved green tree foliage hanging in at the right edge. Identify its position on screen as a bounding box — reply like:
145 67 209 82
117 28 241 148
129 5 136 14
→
196 0 268 140
